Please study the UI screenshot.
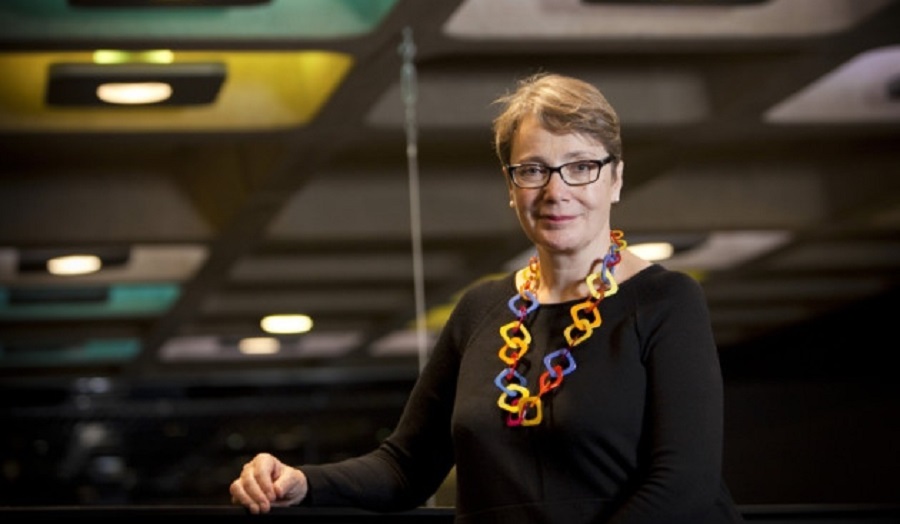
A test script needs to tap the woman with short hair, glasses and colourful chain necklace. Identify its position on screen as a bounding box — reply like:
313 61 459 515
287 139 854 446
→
230 74 741 524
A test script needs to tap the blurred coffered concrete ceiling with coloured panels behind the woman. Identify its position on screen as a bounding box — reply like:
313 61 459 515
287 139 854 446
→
0 0 900 504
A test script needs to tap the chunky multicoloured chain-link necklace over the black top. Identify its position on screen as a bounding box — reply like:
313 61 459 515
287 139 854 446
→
494 229 627 427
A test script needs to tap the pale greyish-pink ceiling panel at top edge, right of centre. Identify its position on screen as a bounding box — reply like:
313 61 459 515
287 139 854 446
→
443 0 890 41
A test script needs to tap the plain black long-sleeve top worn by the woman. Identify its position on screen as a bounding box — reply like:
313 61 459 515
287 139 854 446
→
301 265 741 524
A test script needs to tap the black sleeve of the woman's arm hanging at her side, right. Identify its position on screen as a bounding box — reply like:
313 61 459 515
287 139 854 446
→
610 272 723 524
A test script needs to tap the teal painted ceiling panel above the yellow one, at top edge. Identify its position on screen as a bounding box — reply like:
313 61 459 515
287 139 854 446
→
0 0 397 41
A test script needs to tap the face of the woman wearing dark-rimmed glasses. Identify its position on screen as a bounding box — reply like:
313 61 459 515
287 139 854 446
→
507 116 622 256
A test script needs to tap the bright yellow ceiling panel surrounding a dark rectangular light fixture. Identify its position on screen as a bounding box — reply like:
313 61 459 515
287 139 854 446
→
0 51 353 133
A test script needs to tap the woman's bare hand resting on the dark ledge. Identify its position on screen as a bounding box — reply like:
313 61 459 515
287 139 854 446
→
229 453 309 513
